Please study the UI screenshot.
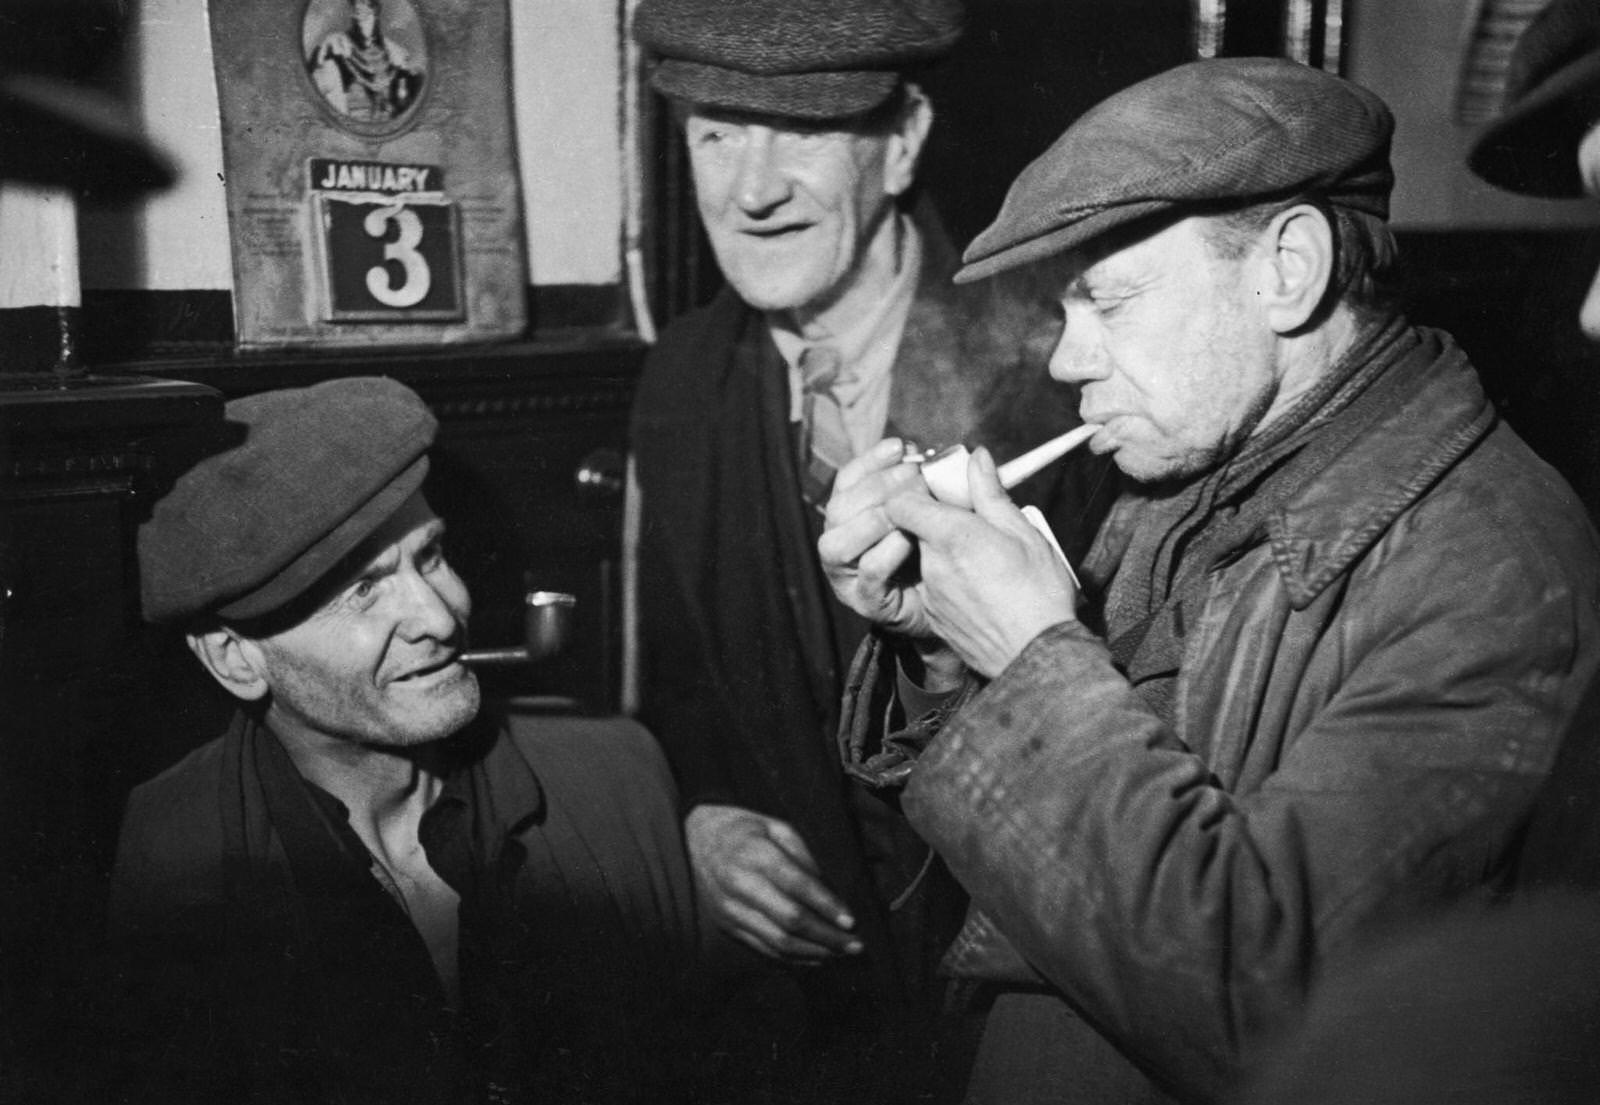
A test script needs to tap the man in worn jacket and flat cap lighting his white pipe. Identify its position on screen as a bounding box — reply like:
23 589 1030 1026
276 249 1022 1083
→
821 59 1600 1102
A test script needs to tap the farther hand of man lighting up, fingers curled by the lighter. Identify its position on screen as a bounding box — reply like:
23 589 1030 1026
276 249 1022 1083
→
816 438 933 638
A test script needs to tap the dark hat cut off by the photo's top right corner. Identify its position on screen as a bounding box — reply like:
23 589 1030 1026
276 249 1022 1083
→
1467 0 1600 198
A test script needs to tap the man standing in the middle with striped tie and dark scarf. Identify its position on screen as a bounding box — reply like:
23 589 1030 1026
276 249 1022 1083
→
634 0 1110 1087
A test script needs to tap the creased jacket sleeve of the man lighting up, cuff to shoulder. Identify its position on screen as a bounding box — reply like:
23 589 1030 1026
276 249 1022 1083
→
904 521 1595 1100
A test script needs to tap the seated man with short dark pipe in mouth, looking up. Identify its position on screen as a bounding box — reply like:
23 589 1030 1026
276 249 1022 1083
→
112 377 694 1102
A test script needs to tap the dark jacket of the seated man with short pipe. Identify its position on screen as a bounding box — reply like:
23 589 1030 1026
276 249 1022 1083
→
103 713 698 1105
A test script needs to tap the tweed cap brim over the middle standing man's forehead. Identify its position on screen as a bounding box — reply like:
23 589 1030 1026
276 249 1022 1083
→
650 58 899 120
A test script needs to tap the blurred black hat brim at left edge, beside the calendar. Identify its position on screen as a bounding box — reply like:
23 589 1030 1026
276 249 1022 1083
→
0 74 174 197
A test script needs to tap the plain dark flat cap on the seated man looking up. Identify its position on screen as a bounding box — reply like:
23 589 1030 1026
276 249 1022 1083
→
139 376 438 622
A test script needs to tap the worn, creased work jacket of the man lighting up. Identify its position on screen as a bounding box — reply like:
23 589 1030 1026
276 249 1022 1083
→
904 324 1600 1102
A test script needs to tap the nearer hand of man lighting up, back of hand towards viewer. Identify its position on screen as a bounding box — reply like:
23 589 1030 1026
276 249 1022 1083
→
883 449 1077 678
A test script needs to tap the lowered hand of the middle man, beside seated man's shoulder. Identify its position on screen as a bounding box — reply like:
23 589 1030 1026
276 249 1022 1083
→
683 804 862 964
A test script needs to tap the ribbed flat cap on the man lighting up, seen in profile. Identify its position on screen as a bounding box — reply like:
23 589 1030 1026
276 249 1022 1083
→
955 58 1394 283
